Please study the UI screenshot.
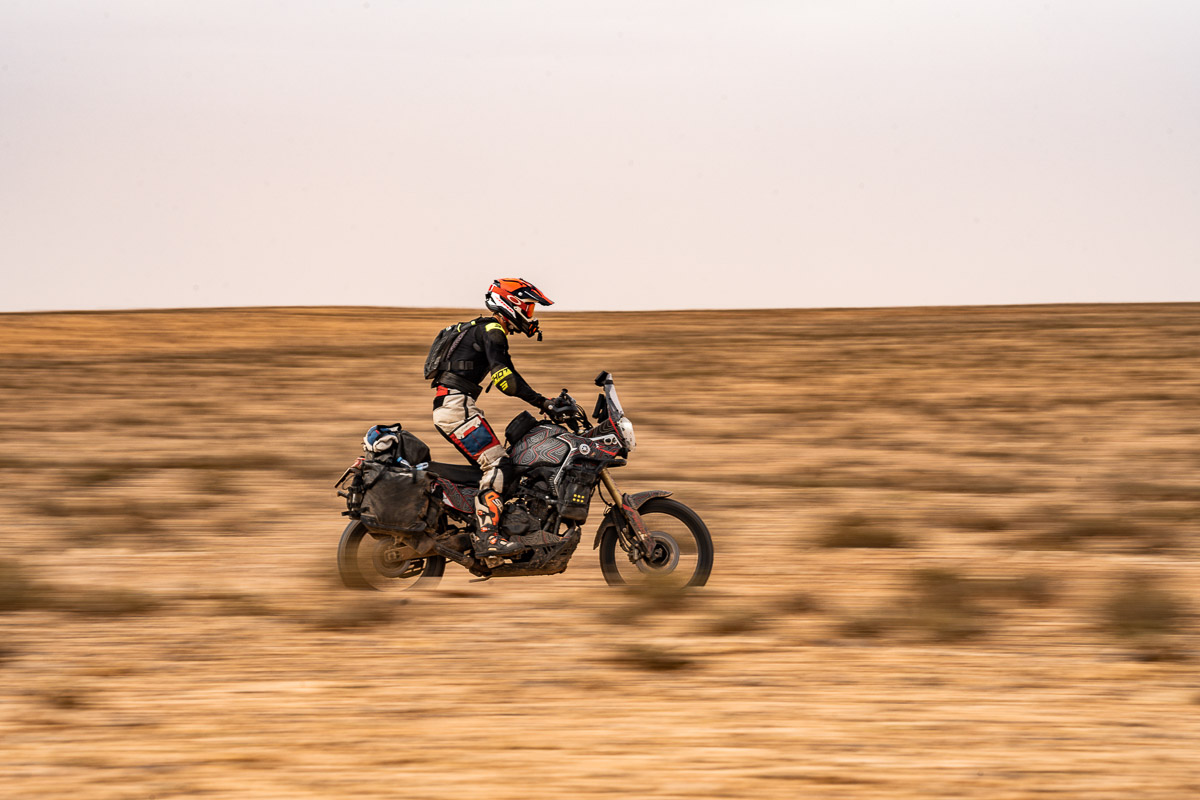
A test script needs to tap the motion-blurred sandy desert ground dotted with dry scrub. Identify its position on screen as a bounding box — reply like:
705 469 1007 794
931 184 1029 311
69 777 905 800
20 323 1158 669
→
0 305 1200 800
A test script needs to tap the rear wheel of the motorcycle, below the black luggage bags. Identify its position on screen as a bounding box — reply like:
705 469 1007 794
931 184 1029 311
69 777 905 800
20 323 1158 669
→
337 519 446 591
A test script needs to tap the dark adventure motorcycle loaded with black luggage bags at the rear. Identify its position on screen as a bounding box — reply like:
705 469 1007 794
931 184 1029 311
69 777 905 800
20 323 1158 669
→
335 372 713 590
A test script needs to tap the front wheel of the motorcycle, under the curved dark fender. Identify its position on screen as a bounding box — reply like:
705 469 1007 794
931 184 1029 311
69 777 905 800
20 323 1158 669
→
600 498 713 589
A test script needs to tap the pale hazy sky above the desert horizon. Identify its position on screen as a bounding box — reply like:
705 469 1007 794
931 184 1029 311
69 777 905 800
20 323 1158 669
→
0 0 1200 311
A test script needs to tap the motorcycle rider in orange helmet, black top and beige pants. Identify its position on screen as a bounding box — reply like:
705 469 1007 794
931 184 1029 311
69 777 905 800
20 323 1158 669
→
432 278 552 555
